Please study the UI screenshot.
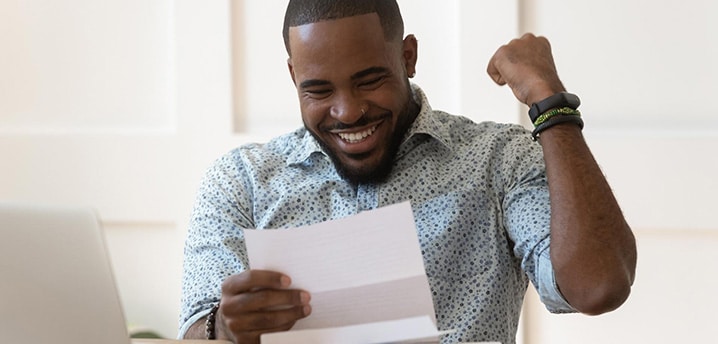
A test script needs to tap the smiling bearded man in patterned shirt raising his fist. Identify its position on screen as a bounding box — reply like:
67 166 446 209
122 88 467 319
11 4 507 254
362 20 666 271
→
180 0 636 343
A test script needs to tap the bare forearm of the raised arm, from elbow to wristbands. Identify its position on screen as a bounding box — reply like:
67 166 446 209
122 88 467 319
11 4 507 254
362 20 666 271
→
539 123 636 314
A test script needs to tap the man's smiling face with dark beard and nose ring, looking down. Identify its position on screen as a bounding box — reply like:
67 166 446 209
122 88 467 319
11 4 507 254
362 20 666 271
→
288 13 418 183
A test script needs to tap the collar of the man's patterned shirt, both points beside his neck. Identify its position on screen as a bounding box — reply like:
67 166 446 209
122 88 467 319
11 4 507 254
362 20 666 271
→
287 84 451 165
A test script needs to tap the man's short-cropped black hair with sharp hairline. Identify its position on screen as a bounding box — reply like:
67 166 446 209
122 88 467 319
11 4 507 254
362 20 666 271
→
282 0 404 56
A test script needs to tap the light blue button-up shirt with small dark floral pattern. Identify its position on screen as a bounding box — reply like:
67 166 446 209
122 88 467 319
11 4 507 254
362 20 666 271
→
179 85 572 343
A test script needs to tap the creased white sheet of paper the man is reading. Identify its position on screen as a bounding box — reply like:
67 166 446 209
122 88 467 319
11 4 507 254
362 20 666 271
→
245 202 438 342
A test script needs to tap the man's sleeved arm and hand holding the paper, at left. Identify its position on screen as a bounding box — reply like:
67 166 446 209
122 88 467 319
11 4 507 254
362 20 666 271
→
180 155 311 343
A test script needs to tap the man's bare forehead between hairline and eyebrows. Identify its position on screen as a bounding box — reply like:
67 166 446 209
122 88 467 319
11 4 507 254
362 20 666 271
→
289 13 394 76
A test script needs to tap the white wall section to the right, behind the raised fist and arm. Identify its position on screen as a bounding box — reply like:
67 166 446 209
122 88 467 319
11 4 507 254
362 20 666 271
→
523 0 718 344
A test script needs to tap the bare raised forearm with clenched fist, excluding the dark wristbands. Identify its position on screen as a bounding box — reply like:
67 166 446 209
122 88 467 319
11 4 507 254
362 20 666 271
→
488 34 636 314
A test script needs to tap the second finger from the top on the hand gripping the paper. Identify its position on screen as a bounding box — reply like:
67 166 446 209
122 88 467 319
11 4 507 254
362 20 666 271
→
222 289 310 315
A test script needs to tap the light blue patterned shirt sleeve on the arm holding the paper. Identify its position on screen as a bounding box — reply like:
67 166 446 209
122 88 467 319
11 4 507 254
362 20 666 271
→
178 151 253 338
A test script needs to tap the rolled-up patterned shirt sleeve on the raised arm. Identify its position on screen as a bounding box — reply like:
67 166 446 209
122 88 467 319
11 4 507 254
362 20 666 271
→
502 130 575 313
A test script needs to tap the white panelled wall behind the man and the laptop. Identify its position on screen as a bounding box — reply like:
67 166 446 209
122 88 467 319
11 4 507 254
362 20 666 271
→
0 0 718 344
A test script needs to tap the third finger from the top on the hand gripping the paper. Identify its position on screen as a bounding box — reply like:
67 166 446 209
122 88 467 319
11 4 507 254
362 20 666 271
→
224 305 312 336
